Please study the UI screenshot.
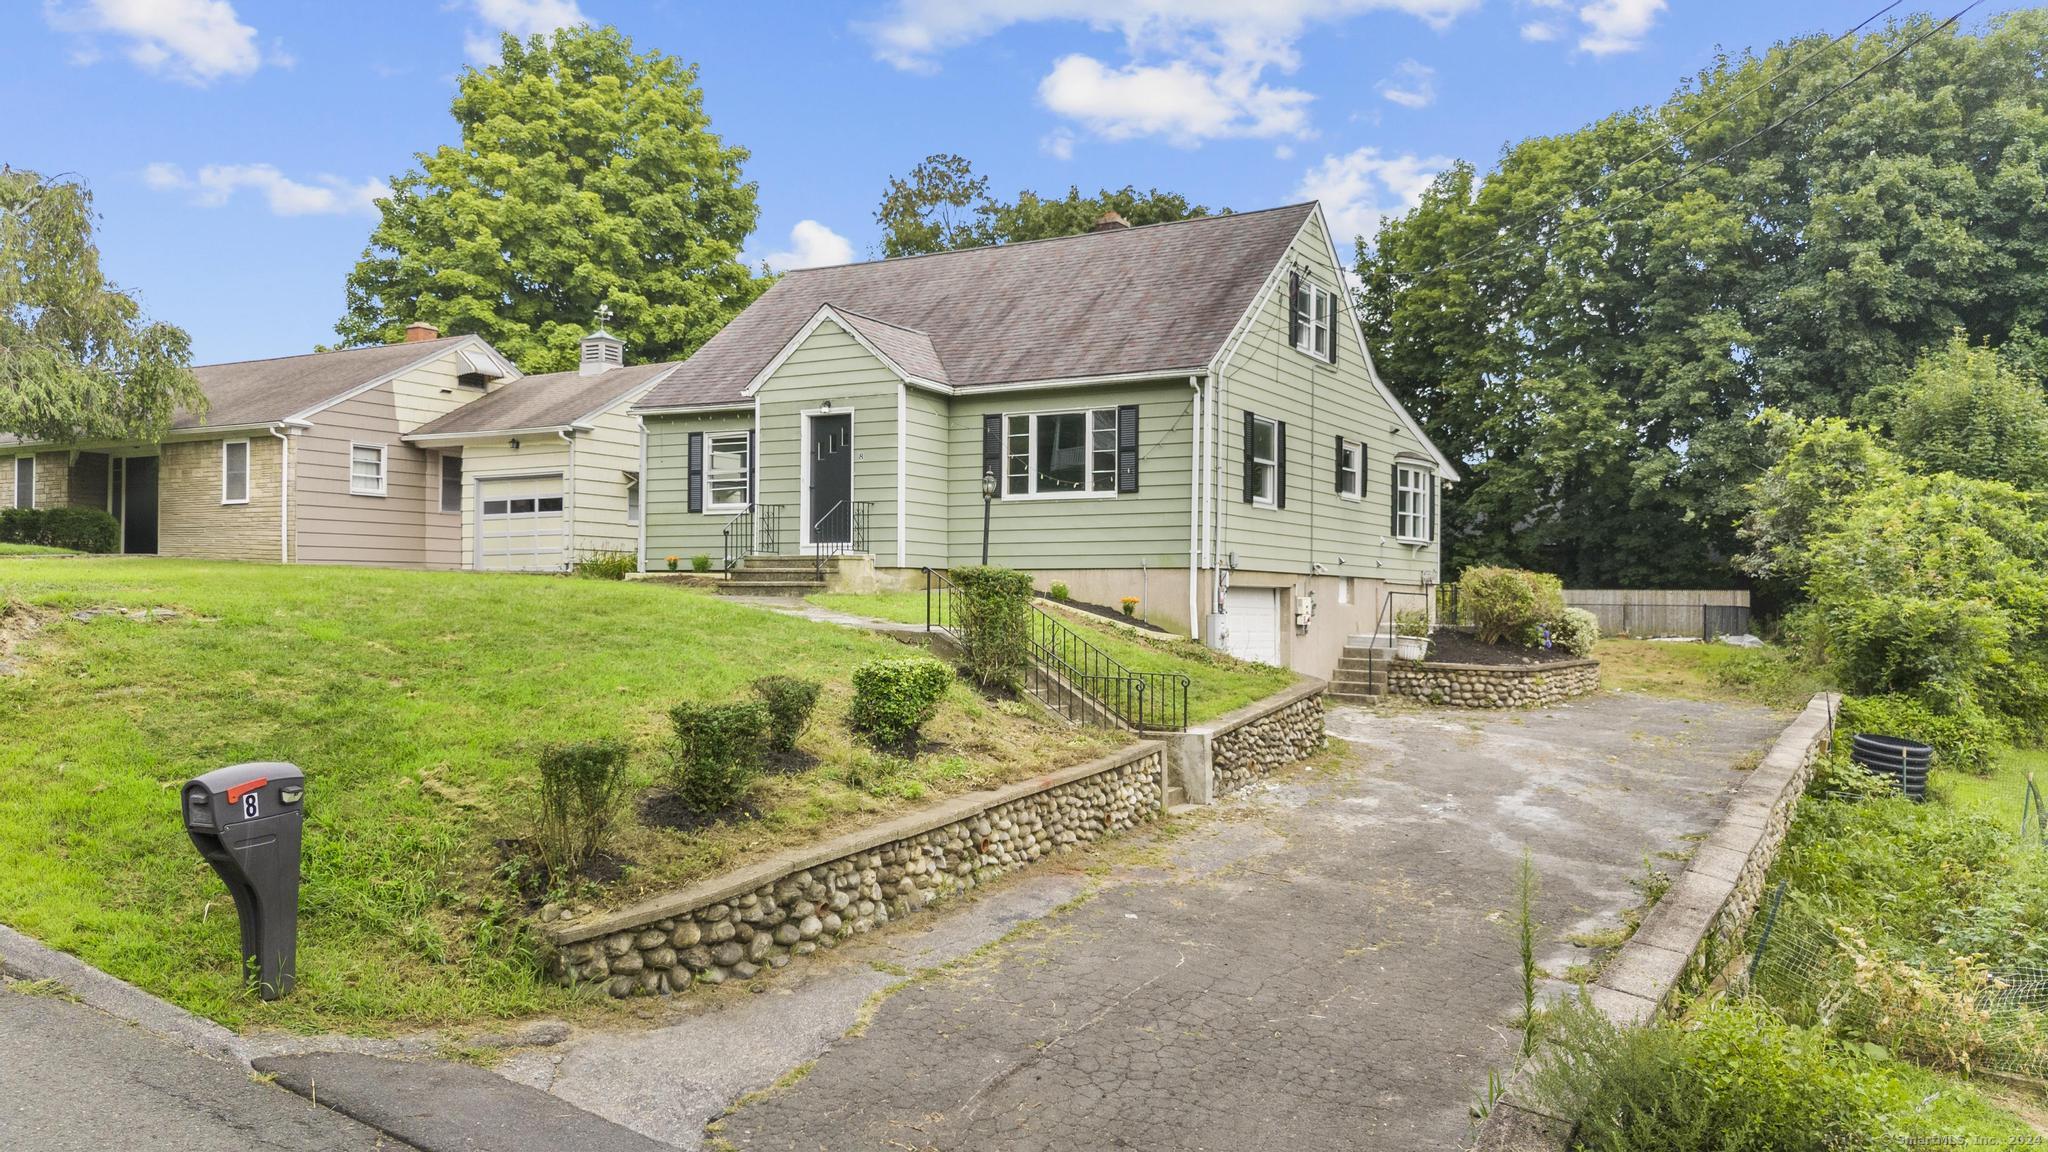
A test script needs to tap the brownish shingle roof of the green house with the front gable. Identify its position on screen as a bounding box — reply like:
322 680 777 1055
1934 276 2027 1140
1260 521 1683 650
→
639 203 1315 408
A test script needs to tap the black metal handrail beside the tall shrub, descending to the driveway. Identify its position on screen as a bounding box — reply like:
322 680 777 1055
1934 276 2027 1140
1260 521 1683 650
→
924 568 1190 732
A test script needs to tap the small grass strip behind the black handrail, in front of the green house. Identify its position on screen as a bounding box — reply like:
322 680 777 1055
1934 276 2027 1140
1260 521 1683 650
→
811 592 1296 724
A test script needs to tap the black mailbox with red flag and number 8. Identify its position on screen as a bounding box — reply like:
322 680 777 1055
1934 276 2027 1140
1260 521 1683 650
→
184 765 305 1000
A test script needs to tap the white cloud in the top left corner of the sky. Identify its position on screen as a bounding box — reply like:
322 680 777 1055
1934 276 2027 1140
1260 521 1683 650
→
43 0 270 86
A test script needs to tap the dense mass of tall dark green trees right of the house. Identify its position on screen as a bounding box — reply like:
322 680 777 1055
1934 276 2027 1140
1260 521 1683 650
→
1358 10 2048 586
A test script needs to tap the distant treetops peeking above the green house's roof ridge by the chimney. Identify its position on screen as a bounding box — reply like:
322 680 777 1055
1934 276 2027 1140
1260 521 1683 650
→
874 154 1229 256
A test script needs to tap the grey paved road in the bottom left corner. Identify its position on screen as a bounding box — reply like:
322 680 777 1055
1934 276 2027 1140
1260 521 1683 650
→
0 986 406 1152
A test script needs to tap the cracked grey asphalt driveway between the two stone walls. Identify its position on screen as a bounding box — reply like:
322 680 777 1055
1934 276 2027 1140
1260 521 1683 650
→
713 693 1784 1152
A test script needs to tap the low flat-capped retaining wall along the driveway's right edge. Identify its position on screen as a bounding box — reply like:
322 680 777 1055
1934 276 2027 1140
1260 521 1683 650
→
1477 693 1841 1152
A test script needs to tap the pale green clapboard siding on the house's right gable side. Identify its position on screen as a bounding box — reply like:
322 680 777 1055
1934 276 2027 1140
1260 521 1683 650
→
1217 208 1442 584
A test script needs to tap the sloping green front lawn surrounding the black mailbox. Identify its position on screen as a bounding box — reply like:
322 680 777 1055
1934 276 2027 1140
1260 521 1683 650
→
0 558 1116 1031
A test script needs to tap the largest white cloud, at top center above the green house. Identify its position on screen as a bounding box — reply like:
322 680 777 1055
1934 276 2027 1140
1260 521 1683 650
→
862 0 1481 146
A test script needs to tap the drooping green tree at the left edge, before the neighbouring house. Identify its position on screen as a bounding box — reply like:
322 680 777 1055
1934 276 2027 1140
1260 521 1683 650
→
0 166 207 441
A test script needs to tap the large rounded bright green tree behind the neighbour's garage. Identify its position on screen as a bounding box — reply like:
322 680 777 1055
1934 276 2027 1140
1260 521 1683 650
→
336 27 766 371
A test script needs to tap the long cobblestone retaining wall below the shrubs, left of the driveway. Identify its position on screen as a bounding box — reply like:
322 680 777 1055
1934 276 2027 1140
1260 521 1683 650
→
541 737 1171 996
